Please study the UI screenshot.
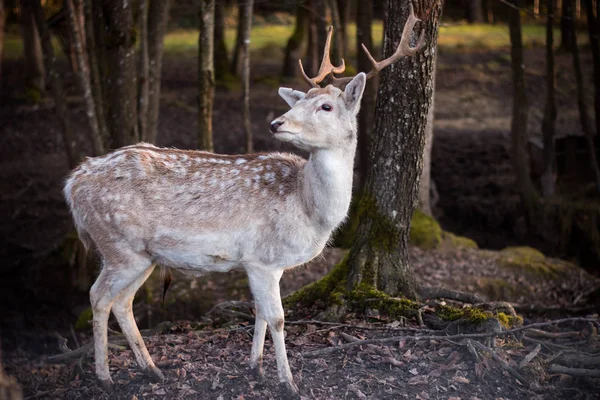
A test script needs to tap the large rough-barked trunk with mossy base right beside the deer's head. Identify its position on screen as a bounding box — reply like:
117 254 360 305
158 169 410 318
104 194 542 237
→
347 0 441 297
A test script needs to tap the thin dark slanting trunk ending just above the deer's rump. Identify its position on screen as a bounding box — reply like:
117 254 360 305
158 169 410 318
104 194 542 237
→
24 0 81 168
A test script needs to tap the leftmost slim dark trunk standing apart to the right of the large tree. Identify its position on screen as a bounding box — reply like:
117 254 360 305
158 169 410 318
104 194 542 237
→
506 0 537 227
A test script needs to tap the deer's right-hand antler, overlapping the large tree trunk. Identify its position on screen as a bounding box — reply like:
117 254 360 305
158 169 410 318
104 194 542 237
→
331 2 425 86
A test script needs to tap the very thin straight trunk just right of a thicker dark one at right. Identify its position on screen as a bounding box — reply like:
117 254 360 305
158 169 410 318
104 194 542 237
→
541 0 556 198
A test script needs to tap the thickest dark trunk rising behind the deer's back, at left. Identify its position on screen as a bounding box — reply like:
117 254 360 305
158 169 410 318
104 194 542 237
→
103 0 139 147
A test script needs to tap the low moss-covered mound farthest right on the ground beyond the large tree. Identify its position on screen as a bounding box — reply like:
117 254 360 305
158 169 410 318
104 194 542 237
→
498 246 576 279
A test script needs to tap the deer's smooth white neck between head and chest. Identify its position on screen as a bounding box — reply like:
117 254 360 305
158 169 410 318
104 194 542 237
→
300 140 356 233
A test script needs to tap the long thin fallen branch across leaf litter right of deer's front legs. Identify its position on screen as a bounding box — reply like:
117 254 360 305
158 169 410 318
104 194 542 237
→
304 318 598 357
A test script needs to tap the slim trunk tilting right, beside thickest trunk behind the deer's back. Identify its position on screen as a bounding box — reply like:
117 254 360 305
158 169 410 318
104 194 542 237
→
144 0 171 143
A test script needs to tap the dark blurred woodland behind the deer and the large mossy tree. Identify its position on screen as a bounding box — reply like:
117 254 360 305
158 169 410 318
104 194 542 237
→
0 0 600 393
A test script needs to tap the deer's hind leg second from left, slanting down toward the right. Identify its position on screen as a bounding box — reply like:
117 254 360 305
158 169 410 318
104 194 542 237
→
112 266 165 381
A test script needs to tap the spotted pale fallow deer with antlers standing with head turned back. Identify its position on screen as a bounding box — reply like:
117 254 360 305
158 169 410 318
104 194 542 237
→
64 6 425 398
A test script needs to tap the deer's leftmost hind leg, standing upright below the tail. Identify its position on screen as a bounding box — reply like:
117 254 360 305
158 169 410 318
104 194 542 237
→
90 248 151 388
